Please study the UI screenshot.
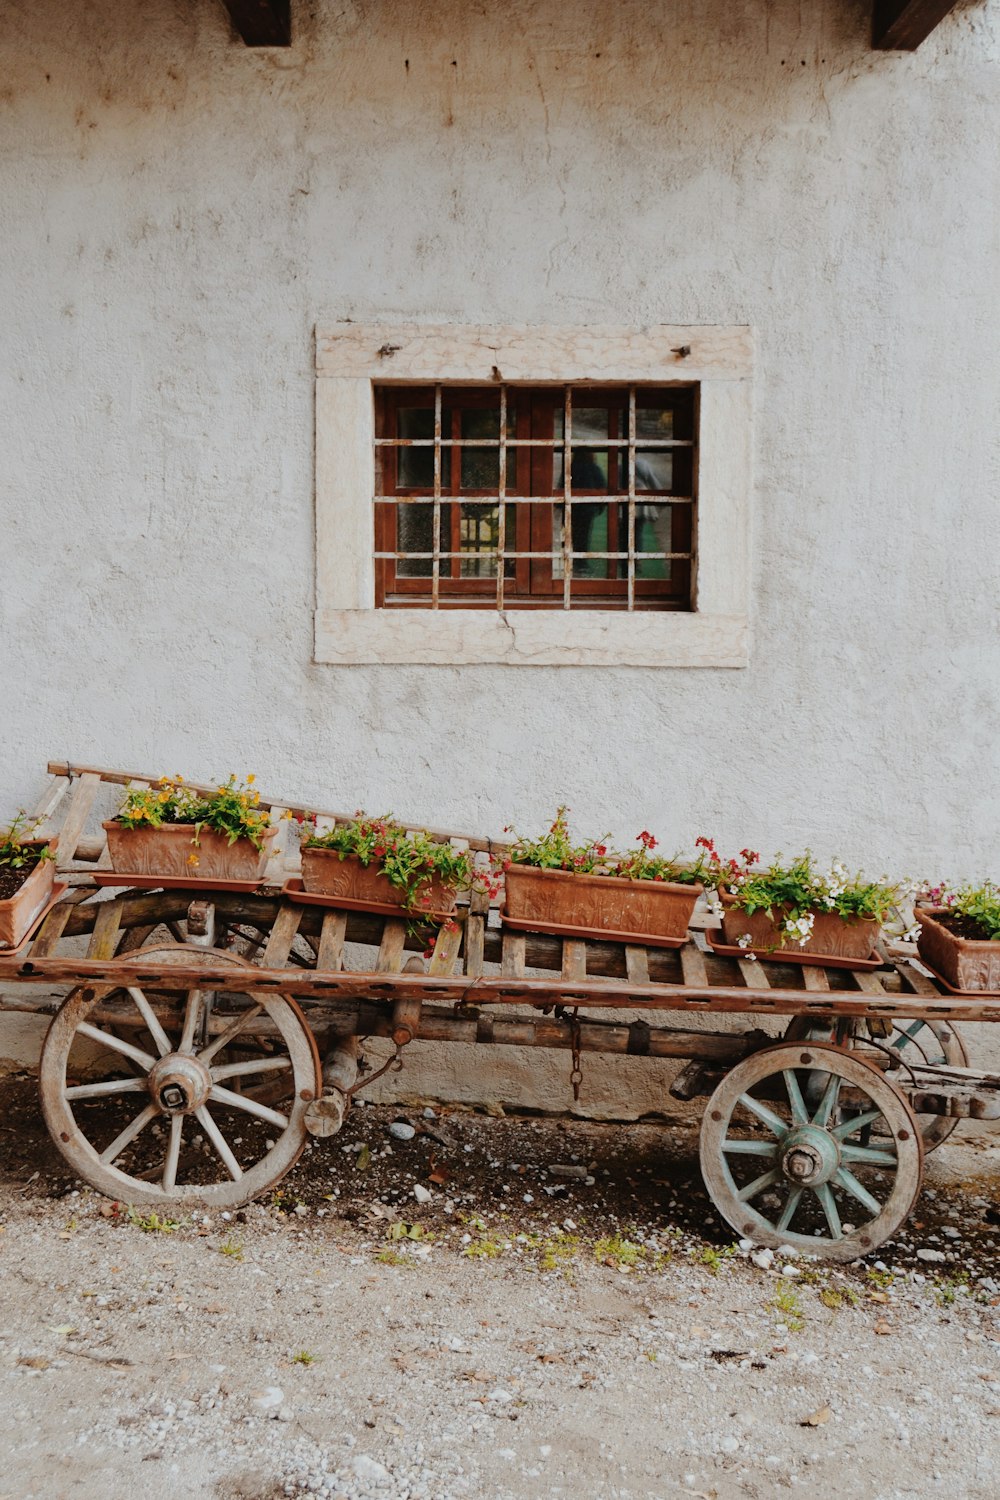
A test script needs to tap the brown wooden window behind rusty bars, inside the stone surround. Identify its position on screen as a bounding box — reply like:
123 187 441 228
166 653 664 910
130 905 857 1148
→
375 384 697 611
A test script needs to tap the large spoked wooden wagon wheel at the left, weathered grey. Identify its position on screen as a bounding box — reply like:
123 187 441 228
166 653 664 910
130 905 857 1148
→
40 944 321 1209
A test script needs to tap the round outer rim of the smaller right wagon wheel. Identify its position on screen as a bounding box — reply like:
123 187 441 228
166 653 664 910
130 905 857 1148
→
700 1044 924 1262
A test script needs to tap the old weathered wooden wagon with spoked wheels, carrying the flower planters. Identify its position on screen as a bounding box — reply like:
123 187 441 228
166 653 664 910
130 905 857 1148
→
0 765 1000 1262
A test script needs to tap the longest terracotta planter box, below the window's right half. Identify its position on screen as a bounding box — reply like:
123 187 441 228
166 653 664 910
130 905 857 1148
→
504 864 703 948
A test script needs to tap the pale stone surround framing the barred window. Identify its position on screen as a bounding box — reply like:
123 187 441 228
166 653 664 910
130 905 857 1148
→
315 323 753 668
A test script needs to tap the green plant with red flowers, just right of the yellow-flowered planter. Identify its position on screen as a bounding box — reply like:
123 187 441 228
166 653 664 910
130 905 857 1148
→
303 812 496 915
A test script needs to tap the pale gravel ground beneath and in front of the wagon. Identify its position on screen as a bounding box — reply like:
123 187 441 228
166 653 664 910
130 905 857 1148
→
0 1079 1000 1500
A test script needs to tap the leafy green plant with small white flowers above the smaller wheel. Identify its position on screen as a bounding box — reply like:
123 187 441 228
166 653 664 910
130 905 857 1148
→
697 839 910 945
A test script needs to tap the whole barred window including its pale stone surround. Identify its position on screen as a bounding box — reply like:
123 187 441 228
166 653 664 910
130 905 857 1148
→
315 323 753 668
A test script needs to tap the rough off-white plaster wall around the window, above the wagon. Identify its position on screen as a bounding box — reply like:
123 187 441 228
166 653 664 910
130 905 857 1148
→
0 0 1000 1092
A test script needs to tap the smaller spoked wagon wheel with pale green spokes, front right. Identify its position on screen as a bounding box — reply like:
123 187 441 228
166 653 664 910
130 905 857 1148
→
700 1043 924 1262
